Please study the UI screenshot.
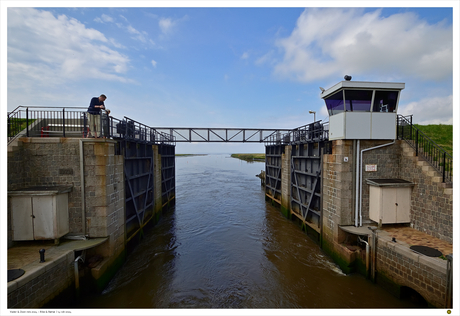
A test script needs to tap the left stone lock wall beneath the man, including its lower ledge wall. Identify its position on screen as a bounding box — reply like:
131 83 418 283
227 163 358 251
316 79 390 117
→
8 137 169 307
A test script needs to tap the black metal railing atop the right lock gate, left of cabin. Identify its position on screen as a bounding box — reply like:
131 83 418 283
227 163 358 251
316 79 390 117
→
265 121 329 145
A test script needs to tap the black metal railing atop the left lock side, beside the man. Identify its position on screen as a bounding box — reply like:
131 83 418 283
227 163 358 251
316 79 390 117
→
8 106 176 145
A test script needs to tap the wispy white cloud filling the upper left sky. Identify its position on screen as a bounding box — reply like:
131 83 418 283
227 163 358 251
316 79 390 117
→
8 8 130 107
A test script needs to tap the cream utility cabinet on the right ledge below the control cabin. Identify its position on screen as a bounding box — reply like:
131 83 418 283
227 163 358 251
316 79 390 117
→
366 179 414 225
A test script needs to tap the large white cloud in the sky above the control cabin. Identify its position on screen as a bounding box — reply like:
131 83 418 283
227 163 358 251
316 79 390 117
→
274 8 453 82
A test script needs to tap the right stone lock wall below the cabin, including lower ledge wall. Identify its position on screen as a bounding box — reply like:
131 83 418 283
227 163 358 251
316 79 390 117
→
322 140 453 307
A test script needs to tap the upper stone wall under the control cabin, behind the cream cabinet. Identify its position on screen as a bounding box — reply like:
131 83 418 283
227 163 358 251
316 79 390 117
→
323 140 453 247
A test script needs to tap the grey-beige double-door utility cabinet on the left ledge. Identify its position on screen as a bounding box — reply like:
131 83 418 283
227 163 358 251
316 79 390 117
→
8 186 72 241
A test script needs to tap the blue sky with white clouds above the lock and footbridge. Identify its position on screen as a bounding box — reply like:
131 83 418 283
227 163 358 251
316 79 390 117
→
1 1 458 153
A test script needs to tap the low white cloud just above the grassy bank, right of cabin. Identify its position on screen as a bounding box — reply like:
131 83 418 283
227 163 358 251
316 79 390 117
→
398 95 453 125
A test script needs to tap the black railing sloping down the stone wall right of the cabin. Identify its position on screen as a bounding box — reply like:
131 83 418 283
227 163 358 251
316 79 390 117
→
398 115 453 183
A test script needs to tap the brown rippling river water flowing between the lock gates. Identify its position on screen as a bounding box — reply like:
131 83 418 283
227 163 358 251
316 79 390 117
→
73 155 415 309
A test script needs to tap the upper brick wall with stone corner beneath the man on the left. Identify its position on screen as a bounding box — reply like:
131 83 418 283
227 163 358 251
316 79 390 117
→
8 137 125 255
